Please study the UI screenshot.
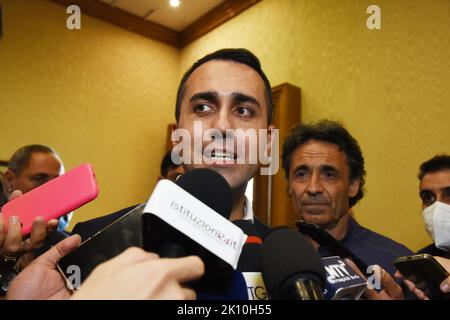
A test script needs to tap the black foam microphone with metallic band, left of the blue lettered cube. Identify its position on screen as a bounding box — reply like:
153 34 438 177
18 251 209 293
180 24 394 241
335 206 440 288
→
261 228 325 300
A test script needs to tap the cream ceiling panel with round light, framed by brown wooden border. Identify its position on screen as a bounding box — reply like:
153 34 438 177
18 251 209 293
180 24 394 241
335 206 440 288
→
100 0 224 31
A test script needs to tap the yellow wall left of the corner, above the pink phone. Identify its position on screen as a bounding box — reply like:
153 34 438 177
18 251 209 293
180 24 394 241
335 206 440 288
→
0 0 179 230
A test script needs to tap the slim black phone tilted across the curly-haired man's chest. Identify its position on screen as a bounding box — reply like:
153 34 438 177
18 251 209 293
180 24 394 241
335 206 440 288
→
295 220 370 276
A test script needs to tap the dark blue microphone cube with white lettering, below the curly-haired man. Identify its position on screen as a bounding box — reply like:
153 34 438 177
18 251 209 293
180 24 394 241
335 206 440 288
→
322 257 367 300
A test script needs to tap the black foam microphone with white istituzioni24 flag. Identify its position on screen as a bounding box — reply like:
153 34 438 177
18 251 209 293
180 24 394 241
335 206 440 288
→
143 169 248 300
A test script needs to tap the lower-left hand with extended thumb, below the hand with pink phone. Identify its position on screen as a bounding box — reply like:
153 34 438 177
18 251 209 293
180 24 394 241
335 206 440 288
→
6 235 81 300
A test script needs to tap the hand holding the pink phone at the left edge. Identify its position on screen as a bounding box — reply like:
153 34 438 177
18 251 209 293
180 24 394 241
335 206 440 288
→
0 190 58 270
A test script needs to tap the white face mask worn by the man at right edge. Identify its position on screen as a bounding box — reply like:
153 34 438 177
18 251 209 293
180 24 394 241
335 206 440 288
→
423 201 450 251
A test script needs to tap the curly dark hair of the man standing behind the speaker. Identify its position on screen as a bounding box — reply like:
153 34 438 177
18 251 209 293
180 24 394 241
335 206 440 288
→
281 120 366 208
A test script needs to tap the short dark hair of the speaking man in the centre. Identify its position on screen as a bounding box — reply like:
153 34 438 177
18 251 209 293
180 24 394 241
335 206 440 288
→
175 49 272 123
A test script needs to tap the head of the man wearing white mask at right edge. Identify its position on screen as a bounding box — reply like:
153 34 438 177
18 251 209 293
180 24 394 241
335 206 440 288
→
418 155 450 258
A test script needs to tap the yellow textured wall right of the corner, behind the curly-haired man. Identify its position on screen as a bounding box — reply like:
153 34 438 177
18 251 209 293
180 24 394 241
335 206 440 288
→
180 0 450 250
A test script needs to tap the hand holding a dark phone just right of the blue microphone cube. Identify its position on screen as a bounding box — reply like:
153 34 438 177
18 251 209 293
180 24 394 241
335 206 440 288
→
345 259 405 300
